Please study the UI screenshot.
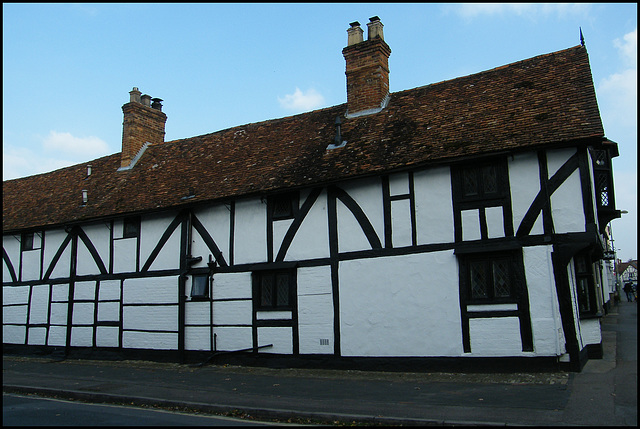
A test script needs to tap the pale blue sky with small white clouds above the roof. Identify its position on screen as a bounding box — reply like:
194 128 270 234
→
2 3 637 260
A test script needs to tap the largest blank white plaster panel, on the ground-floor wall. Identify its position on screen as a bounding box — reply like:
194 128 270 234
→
339 251 462 356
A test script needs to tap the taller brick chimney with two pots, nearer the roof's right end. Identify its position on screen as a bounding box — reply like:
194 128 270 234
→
342 16 391 117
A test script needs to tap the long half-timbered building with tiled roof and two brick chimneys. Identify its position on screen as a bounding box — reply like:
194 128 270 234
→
2 17 620 370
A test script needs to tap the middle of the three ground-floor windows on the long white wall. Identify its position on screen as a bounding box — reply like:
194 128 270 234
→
253 269 296 311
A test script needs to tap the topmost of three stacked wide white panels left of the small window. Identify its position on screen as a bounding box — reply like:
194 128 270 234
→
122 277 178 304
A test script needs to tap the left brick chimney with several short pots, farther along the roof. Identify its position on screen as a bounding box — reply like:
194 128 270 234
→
120 87 167 169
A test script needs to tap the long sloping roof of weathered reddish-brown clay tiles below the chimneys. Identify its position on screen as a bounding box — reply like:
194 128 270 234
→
2 46 604 232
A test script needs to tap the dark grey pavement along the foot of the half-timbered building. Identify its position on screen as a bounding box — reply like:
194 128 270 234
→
2 302 638 426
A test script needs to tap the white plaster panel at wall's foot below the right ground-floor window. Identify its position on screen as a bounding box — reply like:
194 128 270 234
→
469 317 523 356
